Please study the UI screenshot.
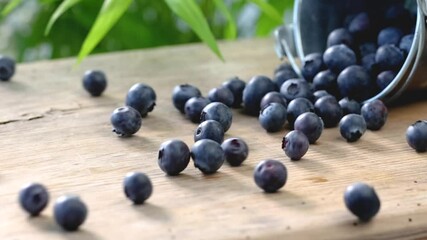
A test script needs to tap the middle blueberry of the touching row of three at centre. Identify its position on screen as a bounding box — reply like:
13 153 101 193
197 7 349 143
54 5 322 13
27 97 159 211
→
191 139 225 174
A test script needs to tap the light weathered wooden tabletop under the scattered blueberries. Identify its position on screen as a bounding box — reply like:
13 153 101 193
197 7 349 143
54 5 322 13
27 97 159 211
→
0 39 427 240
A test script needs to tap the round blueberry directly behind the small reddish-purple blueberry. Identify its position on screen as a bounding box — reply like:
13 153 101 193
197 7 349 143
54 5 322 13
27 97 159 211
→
294 112 323 144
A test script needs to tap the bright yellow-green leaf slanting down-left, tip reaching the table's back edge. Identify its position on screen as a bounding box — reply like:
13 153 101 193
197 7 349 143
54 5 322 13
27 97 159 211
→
77 0 132 63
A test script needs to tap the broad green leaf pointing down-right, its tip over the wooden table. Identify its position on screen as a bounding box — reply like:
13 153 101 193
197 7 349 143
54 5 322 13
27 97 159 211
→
165 0 224 61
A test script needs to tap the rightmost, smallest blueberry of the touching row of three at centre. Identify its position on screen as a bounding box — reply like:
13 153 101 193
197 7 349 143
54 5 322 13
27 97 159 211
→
221 138 249 167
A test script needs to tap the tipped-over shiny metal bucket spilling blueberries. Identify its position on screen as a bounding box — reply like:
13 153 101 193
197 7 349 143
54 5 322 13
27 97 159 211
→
275 0 427 102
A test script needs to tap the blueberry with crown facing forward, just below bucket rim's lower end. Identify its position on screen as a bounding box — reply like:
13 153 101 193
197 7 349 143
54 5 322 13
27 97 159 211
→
339 113 366 142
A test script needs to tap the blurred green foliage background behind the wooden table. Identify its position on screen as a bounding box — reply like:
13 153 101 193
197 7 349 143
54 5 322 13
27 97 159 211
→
0 0 293 62
